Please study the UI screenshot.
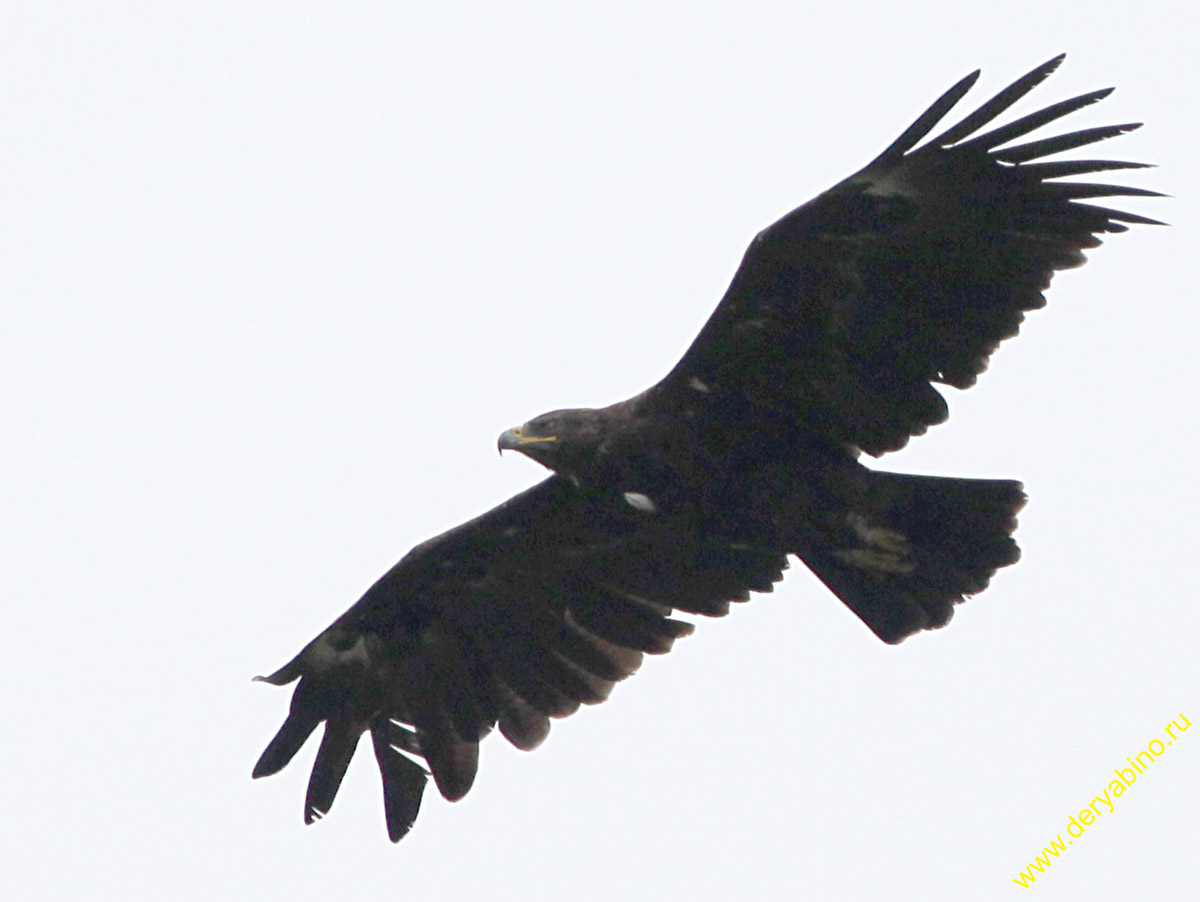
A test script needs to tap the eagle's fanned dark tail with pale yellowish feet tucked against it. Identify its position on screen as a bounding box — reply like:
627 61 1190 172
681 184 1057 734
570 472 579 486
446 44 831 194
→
799 471 1025 643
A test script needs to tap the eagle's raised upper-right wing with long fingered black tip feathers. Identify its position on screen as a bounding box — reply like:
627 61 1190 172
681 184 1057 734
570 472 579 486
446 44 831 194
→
647 56 1158 455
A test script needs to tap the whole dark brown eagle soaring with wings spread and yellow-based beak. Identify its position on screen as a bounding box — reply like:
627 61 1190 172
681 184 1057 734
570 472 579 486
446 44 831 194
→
253 56 1160 842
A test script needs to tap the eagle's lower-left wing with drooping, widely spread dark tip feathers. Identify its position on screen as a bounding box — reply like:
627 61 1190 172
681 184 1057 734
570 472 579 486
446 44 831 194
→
254 476 787 841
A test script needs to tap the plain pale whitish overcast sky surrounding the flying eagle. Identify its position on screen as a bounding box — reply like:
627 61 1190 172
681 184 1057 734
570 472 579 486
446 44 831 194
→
0 0 1200 902
